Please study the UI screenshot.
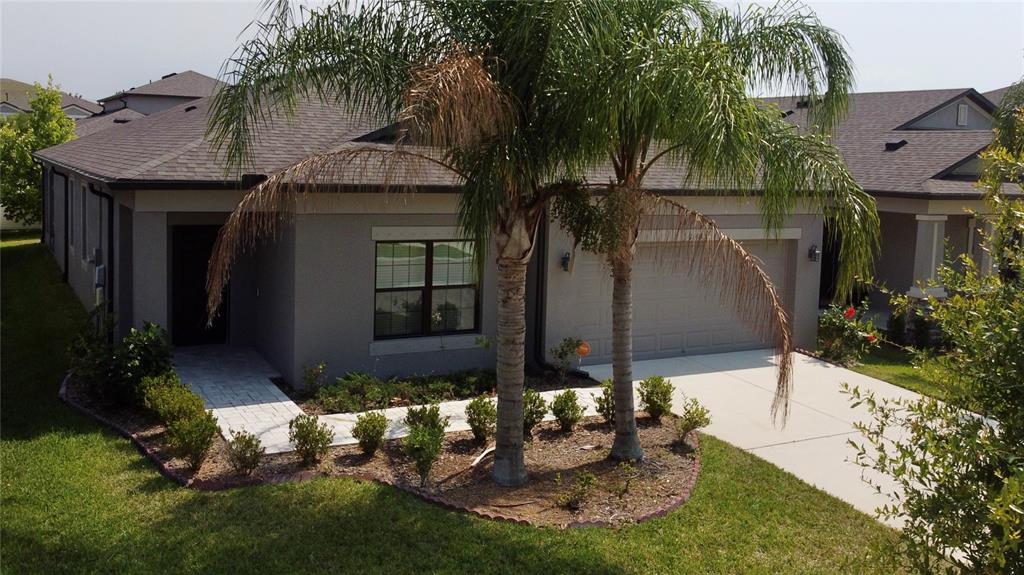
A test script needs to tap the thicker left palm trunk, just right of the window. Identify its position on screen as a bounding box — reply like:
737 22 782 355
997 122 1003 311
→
493 214 536 486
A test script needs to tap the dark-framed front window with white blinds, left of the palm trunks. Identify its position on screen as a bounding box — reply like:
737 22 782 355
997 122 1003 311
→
374 240 479 339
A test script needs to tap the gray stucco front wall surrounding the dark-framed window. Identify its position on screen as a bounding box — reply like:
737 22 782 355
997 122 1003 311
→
279 214 497 385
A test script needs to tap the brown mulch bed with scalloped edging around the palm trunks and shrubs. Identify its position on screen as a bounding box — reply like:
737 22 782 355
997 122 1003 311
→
60 379 700 527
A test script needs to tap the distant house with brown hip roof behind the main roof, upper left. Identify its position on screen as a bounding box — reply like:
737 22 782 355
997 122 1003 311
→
99 70 221 116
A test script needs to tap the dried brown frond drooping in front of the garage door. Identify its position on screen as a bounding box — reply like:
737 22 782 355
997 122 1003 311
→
646 196 793 426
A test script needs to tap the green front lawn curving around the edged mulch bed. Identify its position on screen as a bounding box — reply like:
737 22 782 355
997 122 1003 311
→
0 236 893 574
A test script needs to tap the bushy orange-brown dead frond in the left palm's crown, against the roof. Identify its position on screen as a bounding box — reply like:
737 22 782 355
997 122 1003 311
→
398 48 513 148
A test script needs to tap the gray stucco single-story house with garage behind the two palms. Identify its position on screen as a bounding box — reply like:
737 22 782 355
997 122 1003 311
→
36 98 822 384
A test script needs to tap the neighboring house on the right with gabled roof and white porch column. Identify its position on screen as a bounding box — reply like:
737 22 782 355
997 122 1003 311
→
770 88 1006 311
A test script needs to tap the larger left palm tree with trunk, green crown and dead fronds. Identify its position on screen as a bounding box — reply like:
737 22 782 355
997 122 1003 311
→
207 0 593 485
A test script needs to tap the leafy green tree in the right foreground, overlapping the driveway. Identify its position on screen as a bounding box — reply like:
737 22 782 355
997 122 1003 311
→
851 83 1024 574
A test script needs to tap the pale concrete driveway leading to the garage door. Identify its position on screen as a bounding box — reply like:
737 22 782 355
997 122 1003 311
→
584 350 920 521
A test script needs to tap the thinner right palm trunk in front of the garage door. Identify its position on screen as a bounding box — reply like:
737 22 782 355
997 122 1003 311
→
610 249 643 461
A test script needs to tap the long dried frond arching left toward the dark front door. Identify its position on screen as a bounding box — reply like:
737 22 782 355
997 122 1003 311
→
206 144 461 320
